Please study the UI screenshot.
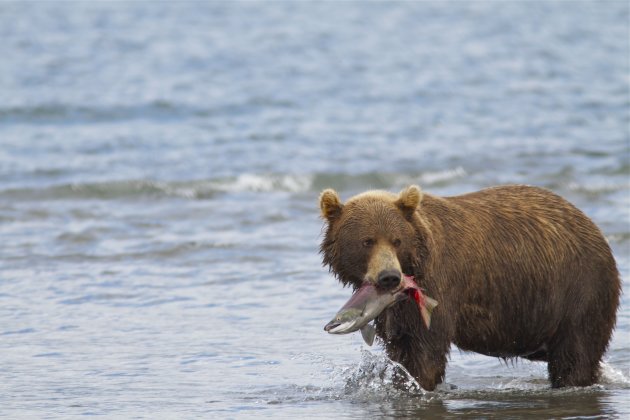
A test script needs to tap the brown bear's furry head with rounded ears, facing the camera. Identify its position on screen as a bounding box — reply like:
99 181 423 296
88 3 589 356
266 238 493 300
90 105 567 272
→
319 185 426 289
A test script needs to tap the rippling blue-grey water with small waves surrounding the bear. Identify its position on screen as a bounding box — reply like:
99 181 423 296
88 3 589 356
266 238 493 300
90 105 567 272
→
0 2 630 418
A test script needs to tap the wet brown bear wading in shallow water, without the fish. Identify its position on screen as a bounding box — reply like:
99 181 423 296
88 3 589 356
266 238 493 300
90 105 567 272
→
320 185 621 390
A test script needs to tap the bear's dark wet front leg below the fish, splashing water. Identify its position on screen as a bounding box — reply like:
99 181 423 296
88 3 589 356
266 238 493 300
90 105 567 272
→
377 302 450 391
